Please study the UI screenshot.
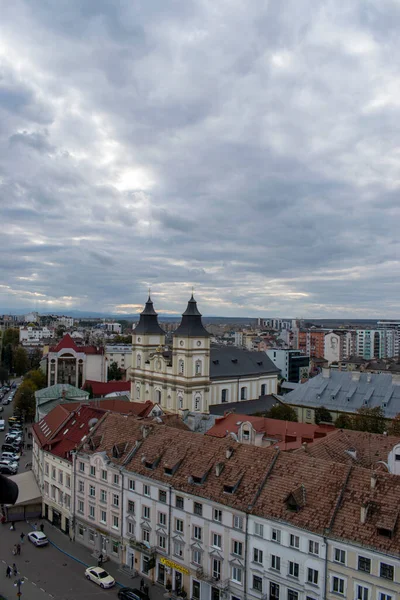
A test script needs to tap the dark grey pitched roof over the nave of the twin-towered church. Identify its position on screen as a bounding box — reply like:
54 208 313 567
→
210 346 280 379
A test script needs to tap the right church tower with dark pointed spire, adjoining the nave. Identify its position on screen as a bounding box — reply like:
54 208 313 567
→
172 294 210 412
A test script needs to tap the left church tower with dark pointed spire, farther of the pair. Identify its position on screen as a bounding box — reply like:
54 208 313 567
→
131 295 165 402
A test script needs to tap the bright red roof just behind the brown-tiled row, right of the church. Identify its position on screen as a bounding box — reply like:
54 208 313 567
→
206 413 335 450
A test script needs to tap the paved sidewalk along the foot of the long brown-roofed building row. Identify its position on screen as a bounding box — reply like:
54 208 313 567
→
30 519 169 600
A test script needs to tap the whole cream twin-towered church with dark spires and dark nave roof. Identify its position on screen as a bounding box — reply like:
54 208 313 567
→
131 296 279 413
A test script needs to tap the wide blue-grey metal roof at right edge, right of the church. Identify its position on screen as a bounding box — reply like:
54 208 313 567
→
283 370 400 419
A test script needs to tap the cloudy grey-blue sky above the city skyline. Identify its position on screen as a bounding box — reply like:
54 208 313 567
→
0 0 400 318
